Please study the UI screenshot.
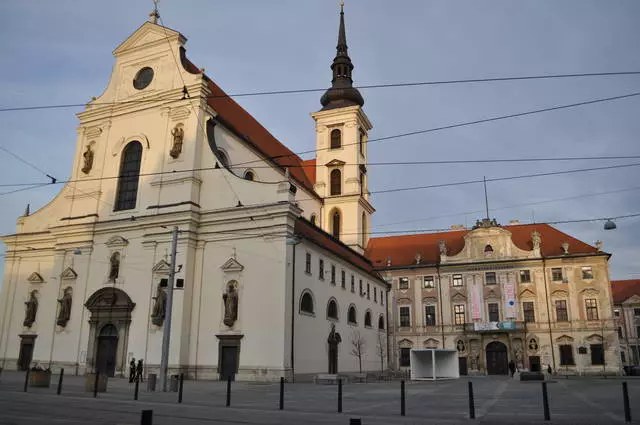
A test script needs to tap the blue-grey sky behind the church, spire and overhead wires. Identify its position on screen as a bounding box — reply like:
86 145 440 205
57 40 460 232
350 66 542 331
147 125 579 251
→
0 0 640 279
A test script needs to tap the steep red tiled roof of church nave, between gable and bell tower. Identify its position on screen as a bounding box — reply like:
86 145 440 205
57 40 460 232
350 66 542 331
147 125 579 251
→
180 50 318 197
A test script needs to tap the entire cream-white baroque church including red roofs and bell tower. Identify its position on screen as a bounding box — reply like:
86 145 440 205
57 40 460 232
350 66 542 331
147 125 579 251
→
0 6 389 380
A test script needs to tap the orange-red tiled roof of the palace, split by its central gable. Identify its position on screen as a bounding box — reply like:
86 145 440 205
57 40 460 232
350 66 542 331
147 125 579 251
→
365 224 598 268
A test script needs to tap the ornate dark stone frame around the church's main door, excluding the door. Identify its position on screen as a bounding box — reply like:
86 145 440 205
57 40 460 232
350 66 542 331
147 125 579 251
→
85 286 136 376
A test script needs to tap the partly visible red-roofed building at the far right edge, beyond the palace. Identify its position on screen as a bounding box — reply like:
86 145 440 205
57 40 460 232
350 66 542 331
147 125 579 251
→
611 279 640 372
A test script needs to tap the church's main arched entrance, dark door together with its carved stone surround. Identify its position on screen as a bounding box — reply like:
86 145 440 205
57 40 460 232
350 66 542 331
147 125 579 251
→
85 287 136 376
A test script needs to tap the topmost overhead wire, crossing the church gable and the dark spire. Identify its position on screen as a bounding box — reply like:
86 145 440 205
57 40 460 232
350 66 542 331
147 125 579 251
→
0 70 640 112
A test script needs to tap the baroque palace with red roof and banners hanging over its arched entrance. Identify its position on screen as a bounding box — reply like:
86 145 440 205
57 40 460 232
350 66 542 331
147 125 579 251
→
368 219 621 374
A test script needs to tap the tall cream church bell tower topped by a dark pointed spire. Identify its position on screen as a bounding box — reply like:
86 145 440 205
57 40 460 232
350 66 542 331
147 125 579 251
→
311 4 375 254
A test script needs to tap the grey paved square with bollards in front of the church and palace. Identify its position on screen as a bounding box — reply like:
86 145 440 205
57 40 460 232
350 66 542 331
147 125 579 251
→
0 372 640 425
